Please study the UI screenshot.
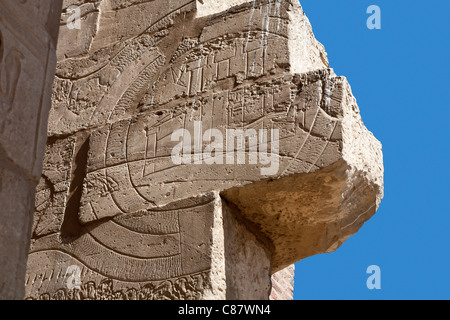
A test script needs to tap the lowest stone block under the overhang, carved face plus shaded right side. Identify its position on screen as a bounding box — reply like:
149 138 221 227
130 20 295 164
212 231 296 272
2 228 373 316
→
26 193 270 300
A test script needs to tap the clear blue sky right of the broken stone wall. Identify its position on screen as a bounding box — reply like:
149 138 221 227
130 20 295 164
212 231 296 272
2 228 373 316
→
294 0 450 299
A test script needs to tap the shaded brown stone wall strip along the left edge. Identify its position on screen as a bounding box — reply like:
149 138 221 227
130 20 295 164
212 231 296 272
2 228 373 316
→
0 0 62 299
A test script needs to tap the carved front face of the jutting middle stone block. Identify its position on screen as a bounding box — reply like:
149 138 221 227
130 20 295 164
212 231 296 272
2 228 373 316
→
80 70 345 222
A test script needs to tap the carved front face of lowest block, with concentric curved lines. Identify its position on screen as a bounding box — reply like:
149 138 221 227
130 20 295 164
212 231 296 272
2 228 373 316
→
27 192 214 299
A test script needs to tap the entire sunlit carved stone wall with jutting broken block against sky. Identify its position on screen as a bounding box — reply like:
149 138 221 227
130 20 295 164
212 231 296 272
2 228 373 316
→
23 0 383 299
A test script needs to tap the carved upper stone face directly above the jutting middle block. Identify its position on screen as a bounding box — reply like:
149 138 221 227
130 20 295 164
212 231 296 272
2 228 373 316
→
50 1 298 134
